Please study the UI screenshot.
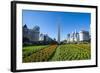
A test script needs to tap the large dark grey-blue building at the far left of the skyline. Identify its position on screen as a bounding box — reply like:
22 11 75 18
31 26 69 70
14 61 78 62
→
23 24 40 42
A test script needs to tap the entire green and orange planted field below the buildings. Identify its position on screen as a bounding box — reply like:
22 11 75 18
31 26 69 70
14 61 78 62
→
23 44 91 63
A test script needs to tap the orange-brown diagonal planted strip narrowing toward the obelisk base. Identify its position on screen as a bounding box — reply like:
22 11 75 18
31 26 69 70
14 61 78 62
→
23 45 57 62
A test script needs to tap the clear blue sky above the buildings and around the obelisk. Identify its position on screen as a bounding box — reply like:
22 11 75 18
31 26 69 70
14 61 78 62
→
22 10 91 40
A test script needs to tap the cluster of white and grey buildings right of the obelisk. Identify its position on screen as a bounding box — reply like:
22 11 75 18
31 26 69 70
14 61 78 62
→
67 30 90 43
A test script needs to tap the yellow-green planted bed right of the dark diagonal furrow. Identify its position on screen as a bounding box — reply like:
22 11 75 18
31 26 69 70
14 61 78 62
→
50 44 91 61
